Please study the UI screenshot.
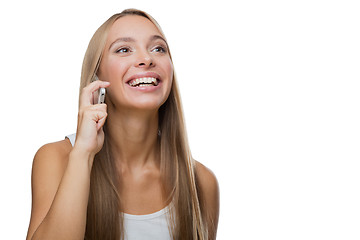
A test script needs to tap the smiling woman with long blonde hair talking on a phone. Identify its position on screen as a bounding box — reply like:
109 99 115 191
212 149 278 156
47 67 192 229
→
27 9 219 240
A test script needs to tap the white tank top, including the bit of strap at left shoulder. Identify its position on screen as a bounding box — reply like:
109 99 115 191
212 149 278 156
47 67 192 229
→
66 134 173 240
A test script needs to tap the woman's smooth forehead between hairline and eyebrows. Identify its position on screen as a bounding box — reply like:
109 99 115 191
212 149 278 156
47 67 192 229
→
108 15 162 41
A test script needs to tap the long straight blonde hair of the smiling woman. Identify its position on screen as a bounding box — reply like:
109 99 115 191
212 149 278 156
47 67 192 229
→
80 9 208 240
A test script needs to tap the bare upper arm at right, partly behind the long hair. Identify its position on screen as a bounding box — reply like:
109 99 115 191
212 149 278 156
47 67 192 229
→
196 162 220 240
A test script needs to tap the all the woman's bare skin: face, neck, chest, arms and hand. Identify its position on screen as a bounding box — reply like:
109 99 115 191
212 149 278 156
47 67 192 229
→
27 16 219 239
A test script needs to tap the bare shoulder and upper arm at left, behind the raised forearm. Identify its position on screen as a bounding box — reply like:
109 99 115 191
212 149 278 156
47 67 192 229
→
28 139 72 237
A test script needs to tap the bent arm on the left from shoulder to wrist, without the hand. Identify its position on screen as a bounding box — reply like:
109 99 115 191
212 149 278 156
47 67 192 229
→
27 140 90 239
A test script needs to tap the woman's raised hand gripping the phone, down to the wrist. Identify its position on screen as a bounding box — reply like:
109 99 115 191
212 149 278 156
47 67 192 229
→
74 81 110 160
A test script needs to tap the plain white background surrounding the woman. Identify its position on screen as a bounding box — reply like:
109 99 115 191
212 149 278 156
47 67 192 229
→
0 0 360 240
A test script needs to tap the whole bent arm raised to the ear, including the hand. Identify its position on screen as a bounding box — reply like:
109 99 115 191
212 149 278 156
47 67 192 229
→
27 81 109 240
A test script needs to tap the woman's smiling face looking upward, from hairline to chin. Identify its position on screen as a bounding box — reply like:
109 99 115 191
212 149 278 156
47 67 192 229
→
98 15 173 109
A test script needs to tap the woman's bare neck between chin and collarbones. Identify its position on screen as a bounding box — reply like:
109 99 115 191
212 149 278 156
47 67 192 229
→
106 109 158 168
